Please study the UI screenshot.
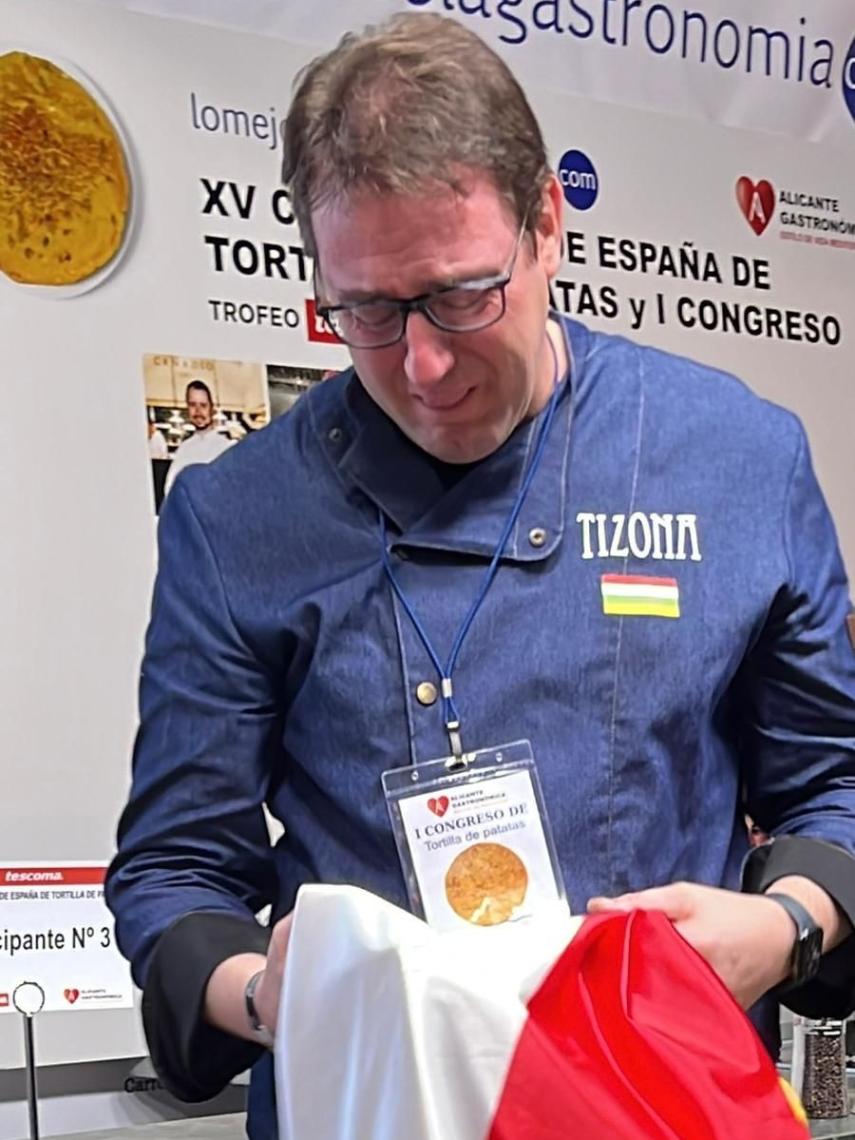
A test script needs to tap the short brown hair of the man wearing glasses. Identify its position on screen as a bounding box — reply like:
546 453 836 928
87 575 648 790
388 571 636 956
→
282 13 549 257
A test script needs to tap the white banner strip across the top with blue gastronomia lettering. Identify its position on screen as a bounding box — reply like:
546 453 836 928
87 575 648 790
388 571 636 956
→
108 0 855 149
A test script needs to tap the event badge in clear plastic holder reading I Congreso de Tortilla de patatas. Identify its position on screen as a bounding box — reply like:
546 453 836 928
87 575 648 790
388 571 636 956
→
383 740 564 930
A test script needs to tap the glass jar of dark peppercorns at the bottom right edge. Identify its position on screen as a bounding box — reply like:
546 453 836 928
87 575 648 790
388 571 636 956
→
790 1015 849 1119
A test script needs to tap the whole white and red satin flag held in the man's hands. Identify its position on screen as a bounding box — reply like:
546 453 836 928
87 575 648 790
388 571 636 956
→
275 886 808 1140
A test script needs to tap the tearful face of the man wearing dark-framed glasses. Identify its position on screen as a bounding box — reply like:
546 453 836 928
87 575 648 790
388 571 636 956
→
312 172 561 463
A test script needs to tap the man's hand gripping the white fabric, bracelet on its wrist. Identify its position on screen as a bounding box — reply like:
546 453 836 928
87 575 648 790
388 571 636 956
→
204 912 293 1041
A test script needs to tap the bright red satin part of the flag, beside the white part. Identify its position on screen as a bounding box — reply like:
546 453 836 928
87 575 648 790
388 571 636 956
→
488 911 808 1140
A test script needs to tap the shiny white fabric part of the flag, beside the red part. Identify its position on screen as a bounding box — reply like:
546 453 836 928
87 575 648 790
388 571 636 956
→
275 886 581 1140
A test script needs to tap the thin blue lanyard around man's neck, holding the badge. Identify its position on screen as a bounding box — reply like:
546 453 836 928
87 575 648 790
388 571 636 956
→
380 334 559 764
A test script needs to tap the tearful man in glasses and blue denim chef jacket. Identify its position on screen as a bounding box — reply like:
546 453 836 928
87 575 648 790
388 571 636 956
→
108 15 855 1138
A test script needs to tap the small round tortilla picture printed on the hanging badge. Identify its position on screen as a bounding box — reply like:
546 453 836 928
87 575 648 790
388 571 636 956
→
446 844 529 926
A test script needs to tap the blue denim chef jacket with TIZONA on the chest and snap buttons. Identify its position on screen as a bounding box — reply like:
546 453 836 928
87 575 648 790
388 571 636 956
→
109 321 855 1137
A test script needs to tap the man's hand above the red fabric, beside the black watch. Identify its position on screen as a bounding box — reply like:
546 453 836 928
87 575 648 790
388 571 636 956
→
588 882 796 1009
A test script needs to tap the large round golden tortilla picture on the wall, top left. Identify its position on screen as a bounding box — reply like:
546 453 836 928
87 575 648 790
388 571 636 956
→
0 51 131 286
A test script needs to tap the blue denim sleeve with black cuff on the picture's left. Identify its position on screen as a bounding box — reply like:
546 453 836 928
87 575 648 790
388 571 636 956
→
106 478 280 1099
